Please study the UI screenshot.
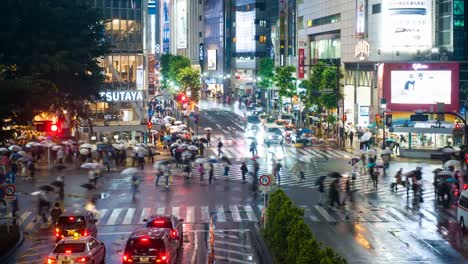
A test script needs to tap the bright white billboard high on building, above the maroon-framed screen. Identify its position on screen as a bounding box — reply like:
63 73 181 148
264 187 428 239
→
382 0 432 51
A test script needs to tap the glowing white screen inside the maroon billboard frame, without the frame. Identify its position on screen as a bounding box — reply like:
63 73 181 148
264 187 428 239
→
391 70 452 104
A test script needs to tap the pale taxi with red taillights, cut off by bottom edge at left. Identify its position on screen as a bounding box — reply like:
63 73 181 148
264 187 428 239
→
45 234 106 264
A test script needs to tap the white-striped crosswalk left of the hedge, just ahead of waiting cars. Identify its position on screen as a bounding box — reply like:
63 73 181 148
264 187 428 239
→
14 204 258 230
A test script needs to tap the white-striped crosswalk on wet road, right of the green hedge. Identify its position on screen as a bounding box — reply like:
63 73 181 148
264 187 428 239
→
270 204 456 223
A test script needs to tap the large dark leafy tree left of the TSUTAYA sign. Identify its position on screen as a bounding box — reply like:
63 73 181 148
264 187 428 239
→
0 0 110 129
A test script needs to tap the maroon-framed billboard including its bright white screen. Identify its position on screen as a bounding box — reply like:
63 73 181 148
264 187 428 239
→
381 63 459 111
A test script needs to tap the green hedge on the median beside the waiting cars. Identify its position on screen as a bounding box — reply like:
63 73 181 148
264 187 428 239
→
263 189 346 264
